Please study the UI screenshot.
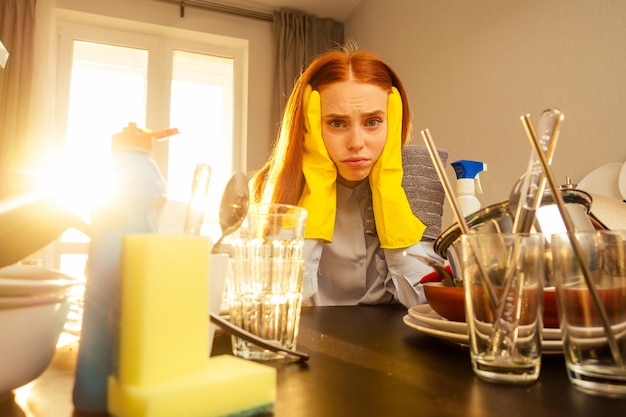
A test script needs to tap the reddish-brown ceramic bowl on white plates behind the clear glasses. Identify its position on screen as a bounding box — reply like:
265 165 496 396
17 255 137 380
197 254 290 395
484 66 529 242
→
424 282 559 328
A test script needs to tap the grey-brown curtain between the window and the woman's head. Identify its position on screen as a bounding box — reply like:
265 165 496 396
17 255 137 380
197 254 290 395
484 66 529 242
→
273 9 344 136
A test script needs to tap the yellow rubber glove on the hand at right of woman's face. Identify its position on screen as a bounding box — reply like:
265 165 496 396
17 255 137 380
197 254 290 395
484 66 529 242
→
370 87 426 249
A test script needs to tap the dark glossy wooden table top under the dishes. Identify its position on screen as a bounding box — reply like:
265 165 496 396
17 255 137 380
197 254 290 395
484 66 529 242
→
0 306 626 417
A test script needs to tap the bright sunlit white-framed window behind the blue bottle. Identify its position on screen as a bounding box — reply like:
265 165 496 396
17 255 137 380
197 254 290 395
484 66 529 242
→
51 22 247 273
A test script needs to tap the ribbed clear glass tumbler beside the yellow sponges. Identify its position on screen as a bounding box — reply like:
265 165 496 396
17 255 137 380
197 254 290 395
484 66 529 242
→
228 204 307 360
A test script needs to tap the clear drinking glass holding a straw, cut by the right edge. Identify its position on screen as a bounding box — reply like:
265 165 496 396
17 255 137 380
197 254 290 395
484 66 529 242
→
551 230 626 397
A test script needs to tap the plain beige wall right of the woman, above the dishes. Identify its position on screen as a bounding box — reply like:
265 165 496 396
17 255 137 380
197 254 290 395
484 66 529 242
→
346 0 626 227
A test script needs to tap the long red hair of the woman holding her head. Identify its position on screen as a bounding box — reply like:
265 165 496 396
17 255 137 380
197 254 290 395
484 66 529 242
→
251 50 411 205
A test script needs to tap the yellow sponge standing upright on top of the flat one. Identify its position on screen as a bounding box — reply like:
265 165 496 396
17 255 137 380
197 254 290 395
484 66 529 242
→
118 234 210 385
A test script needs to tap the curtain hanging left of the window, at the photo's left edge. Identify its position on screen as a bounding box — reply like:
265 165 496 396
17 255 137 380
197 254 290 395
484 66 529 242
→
0 0 35 199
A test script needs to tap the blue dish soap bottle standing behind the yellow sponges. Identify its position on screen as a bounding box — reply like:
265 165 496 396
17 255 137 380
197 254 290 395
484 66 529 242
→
73 123 172 413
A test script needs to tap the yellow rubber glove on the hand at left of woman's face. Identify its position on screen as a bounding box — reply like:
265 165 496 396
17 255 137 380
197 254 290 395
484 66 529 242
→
298 85 337 242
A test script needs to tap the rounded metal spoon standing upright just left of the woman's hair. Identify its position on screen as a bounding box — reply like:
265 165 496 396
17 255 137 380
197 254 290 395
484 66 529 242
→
212 171 250 253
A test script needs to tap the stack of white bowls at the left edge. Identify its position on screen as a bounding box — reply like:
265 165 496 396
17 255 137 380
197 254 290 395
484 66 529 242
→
0 264 84 401
